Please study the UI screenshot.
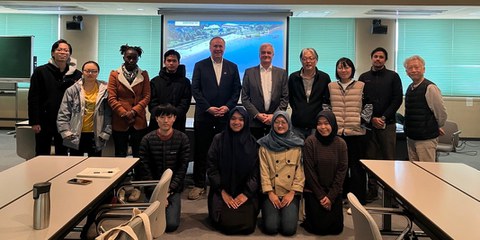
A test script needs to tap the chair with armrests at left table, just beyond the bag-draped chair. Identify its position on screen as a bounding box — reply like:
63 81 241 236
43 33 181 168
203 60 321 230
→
95 169 173 239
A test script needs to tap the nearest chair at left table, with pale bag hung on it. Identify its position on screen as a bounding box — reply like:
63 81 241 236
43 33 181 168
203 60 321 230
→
97 201 160 240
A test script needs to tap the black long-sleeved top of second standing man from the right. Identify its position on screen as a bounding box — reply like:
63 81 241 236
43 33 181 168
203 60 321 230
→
358 68 403 124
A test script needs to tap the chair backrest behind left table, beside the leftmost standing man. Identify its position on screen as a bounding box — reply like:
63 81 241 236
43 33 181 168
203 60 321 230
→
15 126 35 160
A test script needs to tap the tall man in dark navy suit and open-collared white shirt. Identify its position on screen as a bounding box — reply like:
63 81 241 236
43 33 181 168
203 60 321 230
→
188 37 241 200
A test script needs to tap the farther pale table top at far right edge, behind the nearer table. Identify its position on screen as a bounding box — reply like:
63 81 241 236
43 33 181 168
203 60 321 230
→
413 162 480 202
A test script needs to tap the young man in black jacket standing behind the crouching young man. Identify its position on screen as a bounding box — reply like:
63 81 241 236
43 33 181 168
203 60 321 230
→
148 49 192 132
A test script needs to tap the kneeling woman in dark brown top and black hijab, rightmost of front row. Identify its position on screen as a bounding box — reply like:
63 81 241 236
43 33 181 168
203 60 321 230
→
302 110 348 235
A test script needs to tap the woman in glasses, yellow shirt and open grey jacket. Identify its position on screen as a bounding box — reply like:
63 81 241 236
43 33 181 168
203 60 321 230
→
57 61 112 157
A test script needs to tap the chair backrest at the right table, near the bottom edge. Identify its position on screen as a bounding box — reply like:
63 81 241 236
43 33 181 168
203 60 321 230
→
347 193 382 240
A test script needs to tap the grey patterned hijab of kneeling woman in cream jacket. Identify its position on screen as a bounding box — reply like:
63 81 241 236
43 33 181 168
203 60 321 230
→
257 111 303 152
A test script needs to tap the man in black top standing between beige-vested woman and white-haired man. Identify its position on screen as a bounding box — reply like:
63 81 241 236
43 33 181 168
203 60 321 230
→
358 47 403 201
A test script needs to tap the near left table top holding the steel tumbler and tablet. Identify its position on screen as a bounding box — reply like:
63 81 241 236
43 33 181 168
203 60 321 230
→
0 157 138 239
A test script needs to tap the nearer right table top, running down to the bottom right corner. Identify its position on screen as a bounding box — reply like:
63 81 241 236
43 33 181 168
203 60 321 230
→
361 160 480 239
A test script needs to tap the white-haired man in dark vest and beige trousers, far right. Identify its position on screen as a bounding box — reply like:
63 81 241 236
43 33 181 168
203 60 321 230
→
403 55 447 162
